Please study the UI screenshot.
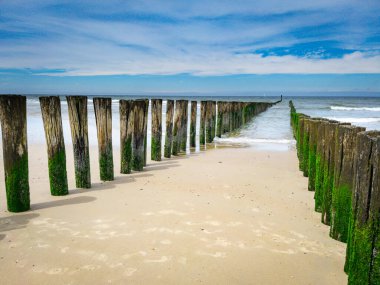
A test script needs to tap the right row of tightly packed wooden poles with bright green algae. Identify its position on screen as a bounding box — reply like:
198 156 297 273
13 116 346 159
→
289 101 380 284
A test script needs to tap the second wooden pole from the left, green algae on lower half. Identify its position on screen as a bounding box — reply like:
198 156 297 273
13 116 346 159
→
39 96 69 196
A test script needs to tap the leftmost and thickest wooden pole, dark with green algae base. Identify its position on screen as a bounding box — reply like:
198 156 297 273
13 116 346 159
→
0 95 30 213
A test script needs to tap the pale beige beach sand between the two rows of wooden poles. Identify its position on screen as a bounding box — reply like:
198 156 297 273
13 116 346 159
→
0 146 347 285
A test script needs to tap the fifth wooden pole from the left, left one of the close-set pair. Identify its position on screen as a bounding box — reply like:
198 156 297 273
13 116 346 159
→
119 100 134 174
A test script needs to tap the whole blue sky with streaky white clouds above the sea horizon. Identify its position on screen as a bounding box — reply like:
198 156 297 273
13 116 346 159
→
0 0 380 94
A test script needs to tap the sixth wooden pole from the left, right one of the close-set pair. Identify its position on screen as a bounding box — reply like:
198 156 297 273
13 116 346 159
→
132 100 146 171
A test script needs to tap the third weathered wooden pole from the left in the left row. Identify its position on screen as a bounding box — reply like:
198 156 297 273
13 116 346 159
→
66 96 91 188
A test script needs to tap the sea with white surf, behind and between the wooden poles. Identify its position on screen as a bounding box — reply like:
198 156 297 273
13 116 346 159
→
5 96 380 152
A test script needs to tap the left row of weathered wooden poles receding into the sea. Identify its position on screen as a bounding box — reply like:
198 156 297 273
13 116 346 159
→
0 95 280 212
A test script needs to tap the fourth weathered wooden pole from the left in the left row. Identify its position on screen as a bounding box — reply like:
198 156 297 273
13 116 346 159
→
93 98 114 181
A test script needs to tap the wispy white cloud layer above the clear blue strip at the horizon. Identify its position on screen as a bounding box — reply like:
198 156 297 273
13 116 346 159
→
0 0 380 76
